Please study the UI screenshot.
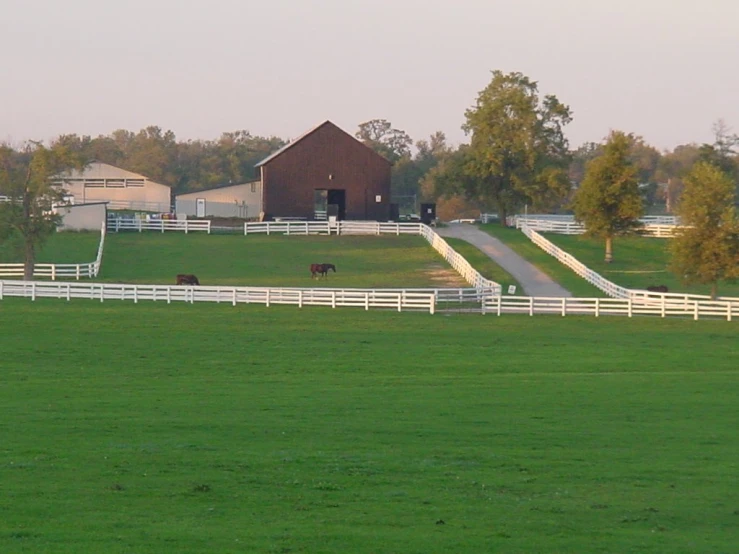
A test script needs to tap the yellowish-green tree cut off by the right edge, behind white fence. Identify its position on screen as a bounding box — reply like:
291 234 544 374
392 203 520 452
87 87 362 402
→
670 162 739 298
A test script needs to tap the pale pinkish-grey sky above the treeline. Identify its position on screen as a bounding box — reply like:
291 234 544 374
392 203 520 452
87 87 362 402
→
0 0 739 149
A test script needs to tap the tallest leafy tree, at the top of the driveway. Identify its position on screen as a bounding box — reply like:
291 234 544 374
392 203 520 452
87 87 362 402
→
462 71 572 224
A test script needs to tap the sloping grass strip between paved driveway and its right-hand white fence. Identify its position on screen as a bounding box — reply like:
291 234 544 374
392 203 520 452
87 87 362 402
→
480 223 606 298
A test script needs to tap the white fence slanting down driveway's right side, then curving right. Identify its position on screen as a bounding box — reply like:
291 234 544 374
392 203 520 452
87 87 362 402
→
521 225 739 304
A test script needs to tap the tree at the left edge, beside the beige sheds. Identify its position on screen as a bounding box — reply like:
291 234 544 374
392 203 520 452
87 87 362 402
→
0 142 81 280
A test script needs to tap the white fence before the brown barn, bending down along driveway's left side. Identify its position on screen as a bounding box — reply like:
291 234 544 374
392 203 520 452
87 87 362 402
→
244 221 502 294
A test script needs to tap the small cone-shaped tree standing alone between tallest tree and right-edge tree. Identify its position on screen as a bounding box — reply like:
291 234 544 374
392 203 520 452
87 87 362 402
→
573 131 642 263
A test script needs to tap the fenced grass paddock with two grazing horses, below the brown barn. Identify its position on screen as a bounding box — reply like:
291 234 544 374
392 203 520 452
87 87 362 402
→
100 233 469 288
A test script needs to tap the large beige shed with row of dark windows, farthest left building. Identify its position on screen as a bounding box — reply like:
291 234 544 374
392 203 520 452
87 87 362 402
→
54 162 171 212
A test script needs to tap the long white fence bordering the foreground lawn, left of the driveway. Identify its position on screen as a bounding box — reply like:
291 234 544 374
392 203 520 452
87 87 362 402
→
0 281 436 314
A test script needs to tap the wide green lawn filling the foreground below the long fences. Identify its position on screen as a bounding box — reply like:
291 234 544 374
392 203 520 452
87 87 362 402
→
0 299 739 554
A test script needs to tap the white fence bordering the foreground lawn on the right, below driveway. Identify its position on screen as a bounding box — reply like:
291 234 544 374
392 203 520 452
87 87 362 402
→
483 295 739 321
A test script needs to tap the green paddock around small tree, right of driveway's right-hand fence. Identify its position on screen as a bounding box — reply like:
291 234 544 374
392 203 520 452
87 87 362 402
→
544 233 739 297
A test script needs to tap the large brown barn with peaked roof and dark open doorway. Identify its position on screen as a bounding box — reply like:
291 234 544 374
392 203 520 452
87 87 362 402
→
256 121 391 221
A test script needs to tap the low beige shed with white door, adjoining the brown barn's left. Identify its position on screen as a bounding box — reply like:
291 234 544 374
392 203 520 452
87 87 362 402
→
175 181 262 219
